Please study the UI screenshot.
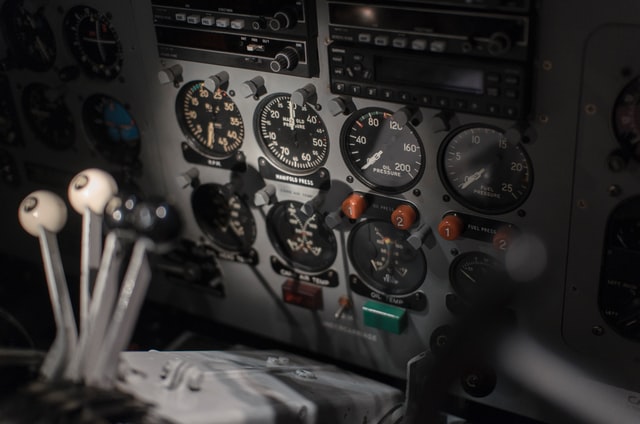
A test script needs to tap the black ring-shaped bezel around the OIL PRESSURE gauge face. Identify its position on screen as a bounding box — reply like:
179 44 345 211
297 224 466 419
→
340 107 427 194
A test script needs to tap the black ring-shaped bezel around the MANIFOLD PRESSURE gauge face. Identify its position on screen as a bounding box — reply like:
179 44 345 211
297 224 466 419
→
253 92 330 175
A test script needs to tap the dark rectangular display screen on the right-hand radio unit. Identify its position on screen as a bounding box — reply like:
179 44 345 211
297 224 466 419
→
375 56 484 94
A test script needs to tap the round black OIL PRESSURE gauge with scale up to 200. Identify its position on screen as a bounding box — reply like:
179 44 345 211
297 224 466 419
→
341 108 425 193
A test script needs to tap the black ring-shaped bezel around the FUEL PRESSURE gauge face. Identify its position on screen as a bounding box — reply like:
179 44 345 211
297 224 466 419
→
438 122 534 215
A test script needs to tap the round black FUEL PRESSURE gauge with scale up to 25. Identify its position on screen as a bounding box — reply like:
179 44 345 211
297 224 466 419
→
439 126 533 214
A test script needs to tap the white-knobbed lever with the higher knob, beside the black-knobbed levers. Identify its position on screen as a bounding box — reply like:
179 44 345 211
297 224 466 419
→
68 168 118 338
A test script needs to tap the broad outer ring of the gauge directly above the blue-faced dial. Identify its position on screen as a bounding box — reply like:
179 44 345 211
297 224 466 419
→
63 5 124 81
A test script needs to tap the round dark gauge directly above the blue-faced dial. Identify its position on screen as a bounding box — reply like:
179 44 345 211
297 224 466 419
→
64 6 122 80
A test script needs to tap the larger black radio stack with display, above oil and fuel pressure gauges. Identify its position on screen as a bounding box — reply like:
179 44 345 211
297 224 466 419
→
328 1 530 119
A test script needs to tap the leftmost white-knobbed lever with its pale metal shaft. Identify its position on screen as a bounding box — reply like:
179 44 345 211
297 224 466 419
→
18 190 78 380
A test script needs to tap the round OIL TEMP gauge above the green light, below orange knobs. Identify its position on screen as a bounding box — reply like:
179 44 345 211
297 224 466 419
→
349 220 427 295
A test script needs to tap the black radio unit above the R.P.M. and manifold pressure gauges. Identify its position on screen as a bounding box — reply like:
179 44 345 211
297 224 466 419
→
152 0 318 77
